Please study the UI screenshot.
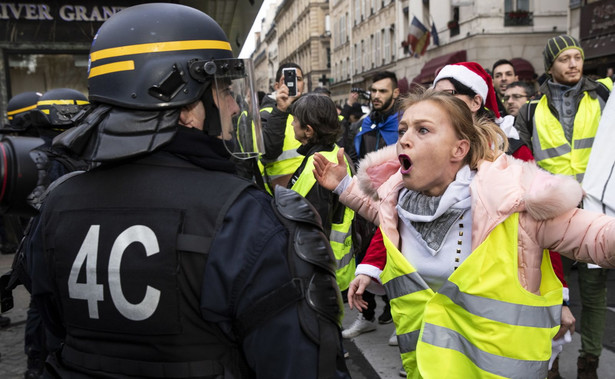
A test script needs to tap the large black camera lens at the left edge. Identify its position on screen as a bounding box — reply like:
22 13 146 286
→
0 136 47 216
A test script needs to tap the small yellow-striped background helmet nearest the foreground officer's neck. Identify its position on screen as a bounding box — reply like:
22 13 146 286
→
32 88 90 129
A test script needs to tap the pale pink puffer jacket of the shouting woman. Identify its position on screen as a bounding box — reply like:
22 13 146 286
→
340 145 615 294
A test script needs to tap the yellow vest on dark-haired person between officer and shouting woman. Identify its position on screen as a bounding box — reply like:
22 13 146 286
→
291 145 356 291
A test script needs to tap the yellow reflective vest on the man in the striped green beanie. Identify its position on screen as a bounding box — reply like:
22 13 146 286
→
532 92 602 182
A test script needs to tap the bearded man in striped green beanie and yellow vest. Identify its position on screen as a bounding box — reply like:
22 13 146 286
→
515 35 613 379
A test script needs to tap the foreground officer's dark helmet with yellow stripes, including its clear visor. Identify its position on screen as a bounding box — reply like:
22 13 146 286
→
88 3 263 157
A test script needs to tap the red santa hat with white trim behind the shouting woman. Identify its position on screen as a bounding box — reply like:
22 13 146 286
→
433 62 500 119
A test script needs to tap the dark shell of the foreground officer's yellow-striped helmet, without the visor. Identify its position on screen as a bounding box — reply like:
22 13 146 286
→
88 3 233 110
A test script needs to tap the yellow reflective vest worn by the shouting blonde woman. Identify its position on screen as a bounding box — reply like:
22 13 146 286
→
381 213 562 378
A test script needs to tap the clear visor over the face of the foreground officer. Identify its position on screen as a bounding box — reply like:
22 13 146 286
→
214 59 265 159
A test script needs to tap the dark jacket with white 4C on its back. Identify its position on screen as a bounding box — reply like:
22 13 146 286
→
31 127 343 378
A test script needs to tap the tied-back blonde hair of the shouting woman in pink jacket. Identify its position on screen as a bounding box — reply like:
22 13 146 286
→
400 89 508 170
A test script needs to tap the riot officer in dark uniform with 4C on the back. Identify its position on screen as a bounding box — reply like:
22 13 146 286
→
26 3 348 378
